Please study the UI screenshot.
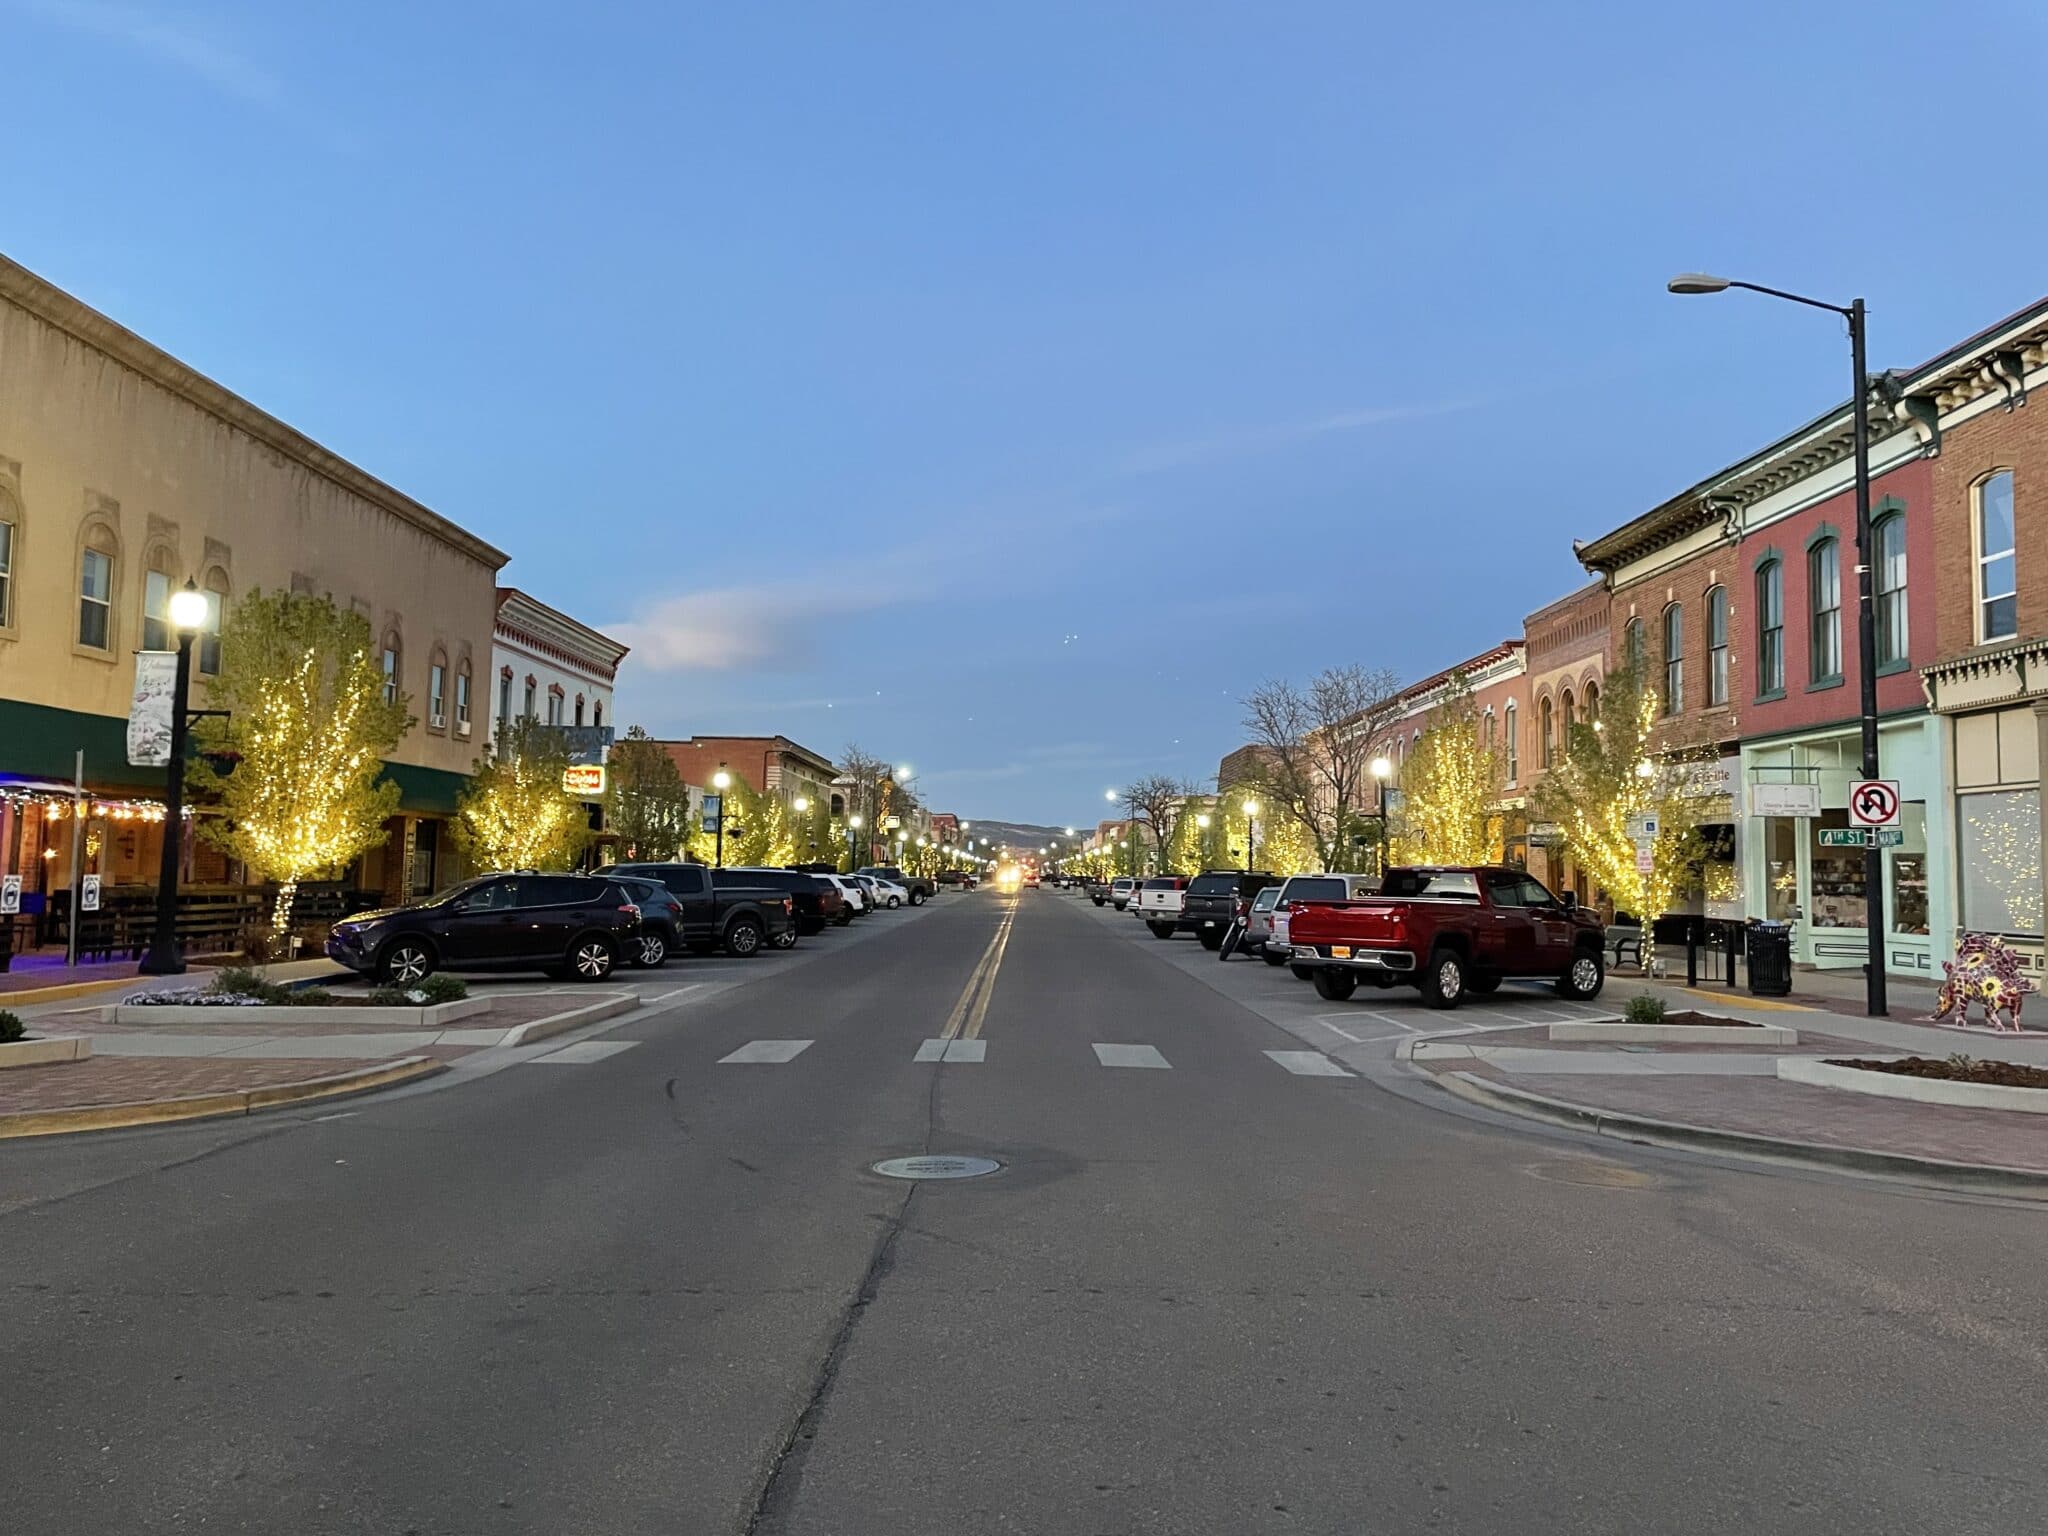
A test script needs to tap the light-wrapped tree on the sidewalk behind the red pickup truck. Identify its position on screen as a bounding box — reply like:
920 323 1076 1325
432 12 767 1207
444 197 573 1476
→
1532 657 1718 971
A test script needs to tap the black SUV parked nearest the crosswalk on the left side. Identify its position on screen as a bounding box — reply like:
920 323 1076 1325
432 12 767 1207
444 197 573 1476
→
328 872 641 987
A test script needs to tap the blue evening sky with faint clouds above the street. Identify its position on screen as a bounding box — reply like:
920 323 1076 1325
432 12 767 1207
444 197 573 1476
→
0 0 2048 821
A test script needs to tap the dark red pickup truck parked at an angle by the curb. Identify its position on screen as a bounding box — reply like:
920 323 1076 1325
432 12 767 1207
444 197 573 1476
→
1288 864 1608 1008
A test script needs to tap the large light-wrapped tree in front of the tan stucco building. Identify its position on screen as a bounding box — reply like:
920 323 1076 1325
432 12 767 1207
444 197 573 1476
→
190 590 412 934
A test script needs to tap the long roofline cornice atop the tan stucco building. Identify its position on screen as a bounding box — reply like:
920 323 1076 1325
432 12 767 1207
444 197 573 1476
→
0 256 510 571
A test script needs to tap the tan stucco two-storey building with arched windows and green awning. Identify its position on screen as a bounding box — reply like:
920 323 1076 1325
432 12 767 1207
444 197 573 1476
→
0 258 506 925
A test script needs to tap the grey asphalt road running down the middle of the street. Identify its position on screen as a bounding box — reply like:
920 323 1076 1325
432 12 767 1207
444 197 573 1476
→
0 891 2048 1536
